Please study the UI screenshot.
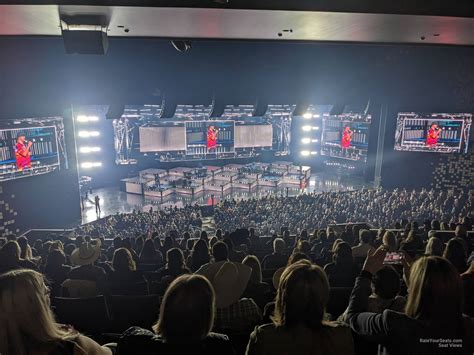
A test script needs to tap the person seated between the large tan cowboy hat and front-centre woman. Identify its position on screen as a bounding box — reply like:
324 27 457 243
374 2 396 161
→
242 255 271 309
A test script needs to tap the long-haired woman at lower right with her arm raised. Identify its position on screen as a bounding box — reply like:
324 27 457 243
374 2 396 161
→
347 249 474 355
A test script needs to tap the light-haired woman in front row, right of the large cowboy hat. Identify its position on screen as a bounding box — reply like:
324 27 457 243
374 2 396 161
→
246 261 354 355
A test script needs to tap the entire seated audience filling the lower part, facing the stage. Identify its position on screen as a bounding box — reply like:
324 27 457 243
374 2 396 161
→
0 190 474 355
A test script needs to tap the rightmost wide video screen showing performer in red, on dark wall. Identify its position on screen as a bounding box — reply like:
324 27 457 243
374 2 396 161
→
395 113 472 153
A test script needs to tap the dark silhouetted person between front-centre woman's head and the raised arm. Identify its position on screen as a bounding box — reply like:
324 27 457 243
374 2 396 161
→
324 242 357 287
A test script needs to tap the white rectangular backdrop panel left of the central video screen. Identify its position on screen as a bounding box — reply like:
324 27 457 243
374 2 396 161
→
139 126 186 153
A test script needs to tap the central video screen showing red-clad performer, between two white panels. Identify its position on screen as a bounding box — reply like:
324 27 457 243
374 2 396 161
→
185 121 234 155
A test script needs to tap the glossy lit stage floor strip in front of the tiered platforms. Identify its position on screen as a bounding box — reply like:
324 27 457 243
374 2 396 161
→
82 172 372 223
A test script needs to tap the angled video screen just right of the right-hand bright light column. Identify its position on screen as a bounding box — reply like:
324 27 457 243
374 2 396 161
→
321 114 371 162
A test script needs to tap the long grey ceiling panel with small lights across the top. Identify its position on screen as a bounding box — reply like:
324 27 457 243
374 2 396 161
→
0 5 474 46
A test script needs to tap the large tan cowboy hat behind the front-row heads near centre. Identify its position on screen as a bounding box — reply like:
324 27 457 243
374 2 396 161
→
196 261 252 308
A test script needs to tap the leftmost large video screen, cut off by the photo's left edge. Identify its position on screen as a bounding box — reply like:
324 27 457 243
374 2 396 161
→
0 117 67 181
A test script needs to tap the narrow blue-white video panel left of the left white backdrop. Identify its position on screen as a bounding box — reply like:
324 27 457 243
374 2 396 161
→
112 118 137 164
